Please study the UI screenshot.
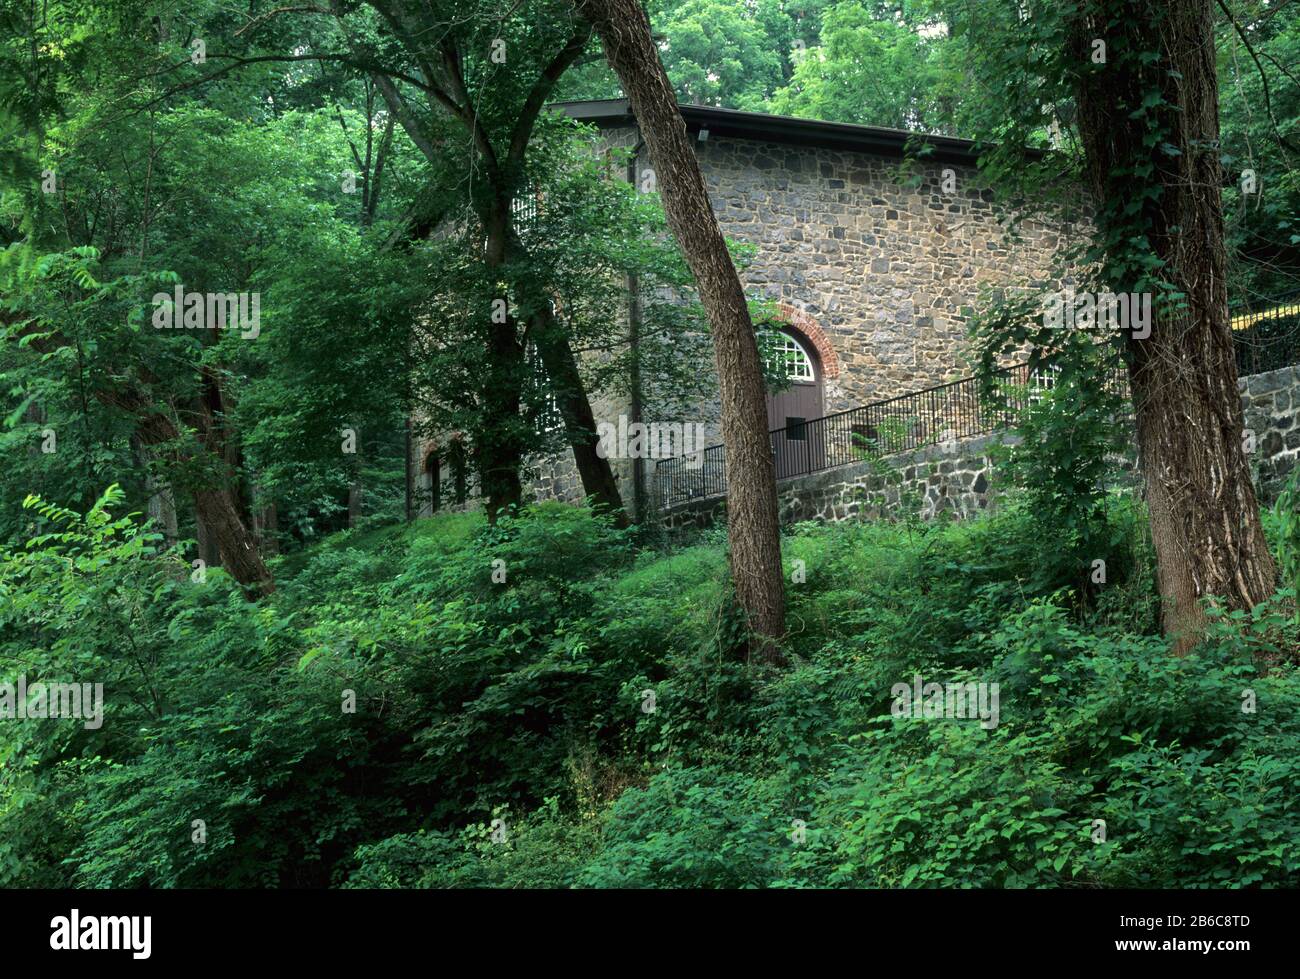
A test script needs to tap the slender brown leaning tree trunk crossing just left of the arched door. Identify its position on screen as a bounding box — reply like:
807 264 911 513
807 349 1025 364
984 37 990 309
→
576 0 785 659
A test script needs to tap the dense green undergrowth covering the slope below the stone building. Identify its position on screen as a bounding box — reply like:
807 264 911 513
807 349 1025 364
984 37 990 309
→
0 481 1300 887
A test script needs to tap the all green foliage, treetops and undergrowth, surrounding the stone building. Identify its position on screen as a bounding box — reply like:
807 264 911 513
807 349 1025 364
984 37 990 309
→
0 0 1300 888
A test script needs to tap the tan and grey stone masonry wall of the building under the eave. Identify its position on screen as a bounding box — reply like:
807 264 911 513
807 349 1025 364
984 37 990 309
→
534 122 1082 512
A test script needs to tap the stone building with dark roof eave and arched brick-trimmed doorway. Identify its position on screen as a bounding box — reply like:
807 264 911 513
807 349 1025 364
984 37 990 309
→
418 99 1076 520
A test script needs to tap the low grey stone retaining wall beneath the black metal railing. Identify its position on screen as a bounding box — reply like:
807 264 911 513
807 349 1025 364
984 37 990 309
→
659 367 1300 532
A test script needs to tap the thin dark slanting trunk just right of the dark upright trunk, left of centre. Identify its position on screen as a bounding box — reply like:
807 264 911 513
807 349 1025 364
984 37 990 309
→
532 308 628 527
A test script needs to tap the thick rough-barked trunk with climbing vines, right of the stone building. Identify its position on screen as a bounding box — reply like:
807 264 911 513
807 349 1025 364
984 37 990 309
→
1071 0 1275 654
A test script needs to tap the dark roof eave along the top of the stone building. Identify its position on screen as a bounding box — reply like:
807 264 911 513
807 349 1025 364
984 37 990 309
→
551 99 1024 165
